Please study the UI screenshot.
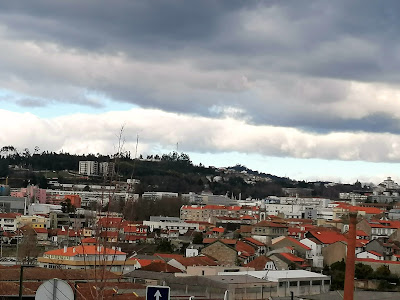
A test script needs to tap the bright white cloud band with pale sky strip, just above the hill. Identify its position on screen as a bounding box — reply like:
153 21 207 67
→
0 108 400 162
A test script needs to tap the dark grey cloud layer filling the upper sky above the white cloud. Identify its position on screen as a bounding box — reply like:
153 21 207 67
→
0 0 400 146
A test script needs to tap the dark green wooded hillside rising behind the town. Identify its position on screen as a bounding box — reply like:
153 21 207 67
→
0 146 364 199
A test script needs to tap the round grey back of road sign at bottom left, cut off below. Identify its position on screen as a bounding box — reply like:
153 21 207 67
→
35 278 74 300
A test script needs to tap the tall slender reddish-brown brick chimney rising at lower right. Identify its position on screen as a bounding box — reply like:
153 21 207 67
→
343 212 357 300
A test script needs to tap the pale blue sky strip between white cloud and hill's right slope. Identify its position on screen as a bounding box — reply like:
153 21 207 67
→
188 152 400 184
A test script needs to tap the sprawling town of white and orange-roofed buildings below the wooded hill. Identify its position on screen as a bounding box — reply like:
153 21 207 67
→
0 161 400 299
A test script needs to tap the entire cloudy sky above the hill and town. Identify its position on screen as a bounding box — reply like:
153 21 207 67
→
0 0 400 184
